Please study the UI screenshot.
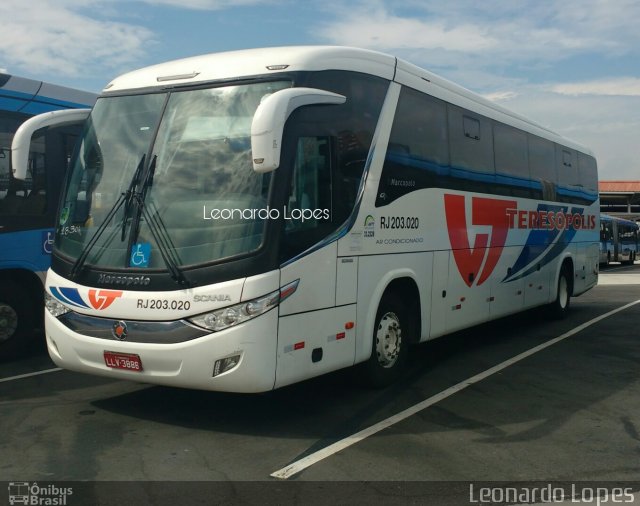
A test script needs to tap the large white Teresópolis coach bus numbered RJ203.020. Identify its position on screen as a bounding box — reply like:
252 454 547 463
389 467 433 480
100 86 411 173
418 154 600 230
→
12 47 599 392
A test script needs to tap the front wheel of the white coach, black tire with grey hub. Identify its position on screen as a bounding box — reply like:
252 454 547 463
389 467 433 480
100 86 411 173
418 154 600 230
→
362 292 412 388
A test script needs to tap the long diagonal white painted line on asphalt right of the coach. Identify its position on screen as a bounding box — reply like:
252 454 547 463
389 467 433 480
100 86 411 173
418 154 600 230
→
271 299 640 479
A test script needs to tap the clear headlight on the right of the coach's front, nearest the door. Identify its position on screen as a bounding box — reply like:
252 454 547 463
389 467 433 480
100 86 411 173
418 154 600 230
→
188 279 300 332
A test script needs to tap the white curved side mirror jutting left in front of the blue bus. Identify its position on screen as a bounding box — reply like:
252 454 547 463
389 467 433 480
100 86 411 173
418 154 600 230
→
11 109 91 180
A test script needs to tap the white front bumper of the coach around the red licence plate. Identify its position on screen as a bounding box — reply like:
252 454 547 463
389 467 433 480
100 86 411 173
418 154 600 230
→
45 308 278 392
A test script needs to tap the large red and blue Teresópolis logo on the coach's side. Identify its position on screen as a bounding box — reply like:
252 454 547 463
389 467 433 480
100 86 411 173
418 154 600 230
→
444 194 596 287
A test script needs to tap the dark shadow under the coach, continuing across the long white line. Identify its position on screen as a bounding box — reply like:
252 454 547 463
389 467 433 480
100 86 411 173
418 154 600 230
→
92 298 640 444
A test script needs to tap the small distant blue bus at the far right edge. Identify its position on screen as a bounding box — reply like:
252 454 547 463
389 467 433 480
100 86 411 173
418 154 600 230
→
600 214 638 265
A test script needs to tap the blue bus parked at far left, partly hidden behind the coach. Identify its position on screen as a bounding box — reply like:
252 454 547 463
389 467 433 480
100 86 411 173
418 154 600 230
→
0 74 96 356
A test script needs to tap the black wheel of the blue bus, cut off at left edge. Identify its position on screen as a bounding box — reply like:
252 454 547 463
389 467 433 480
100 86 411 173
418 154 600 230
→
0 281 40 359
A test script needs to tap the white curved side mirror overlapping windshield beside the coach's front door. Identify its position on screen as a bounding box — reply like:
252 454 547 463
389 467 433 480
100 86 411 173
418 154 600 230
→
251 88 347 173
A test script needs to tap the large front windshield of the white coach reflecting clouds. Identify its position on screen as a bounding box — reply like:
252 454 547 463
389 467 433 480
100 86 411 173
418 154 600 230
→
56 81 291 268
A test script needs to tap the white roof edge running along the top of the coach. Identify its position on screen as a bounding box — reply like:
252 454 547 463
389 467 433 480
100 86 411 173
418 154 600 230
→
103 45 594 156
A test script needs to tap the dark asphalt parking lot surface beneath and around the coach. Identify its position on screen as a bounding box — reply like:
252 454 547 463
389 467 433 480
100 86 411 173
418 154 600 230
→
0 264 640 504
